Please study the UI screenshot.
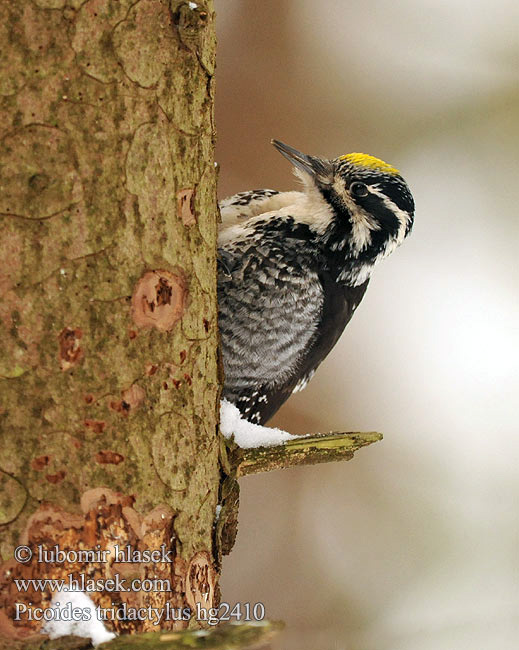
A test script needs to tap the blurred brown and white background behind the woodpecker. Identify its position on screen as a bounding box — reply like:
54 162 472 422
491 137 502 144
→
216 0 519 650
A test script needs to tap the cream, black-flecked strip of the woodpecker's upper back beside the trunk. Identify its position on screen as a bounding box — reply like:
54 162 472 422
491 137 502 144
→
218 189 300 231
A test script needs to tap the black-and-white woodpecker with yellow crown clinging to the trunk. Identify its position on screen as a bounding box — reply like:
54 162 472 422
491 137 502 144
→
218 140 414 424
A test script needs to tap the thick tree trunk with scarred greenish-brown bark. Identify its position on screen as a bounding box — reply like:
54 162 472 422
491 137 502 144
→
0 0 220 647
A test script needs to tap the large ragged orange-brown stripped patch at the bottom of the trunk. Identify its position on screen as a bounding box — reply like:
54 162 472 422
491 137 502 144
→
0 487 179 636
